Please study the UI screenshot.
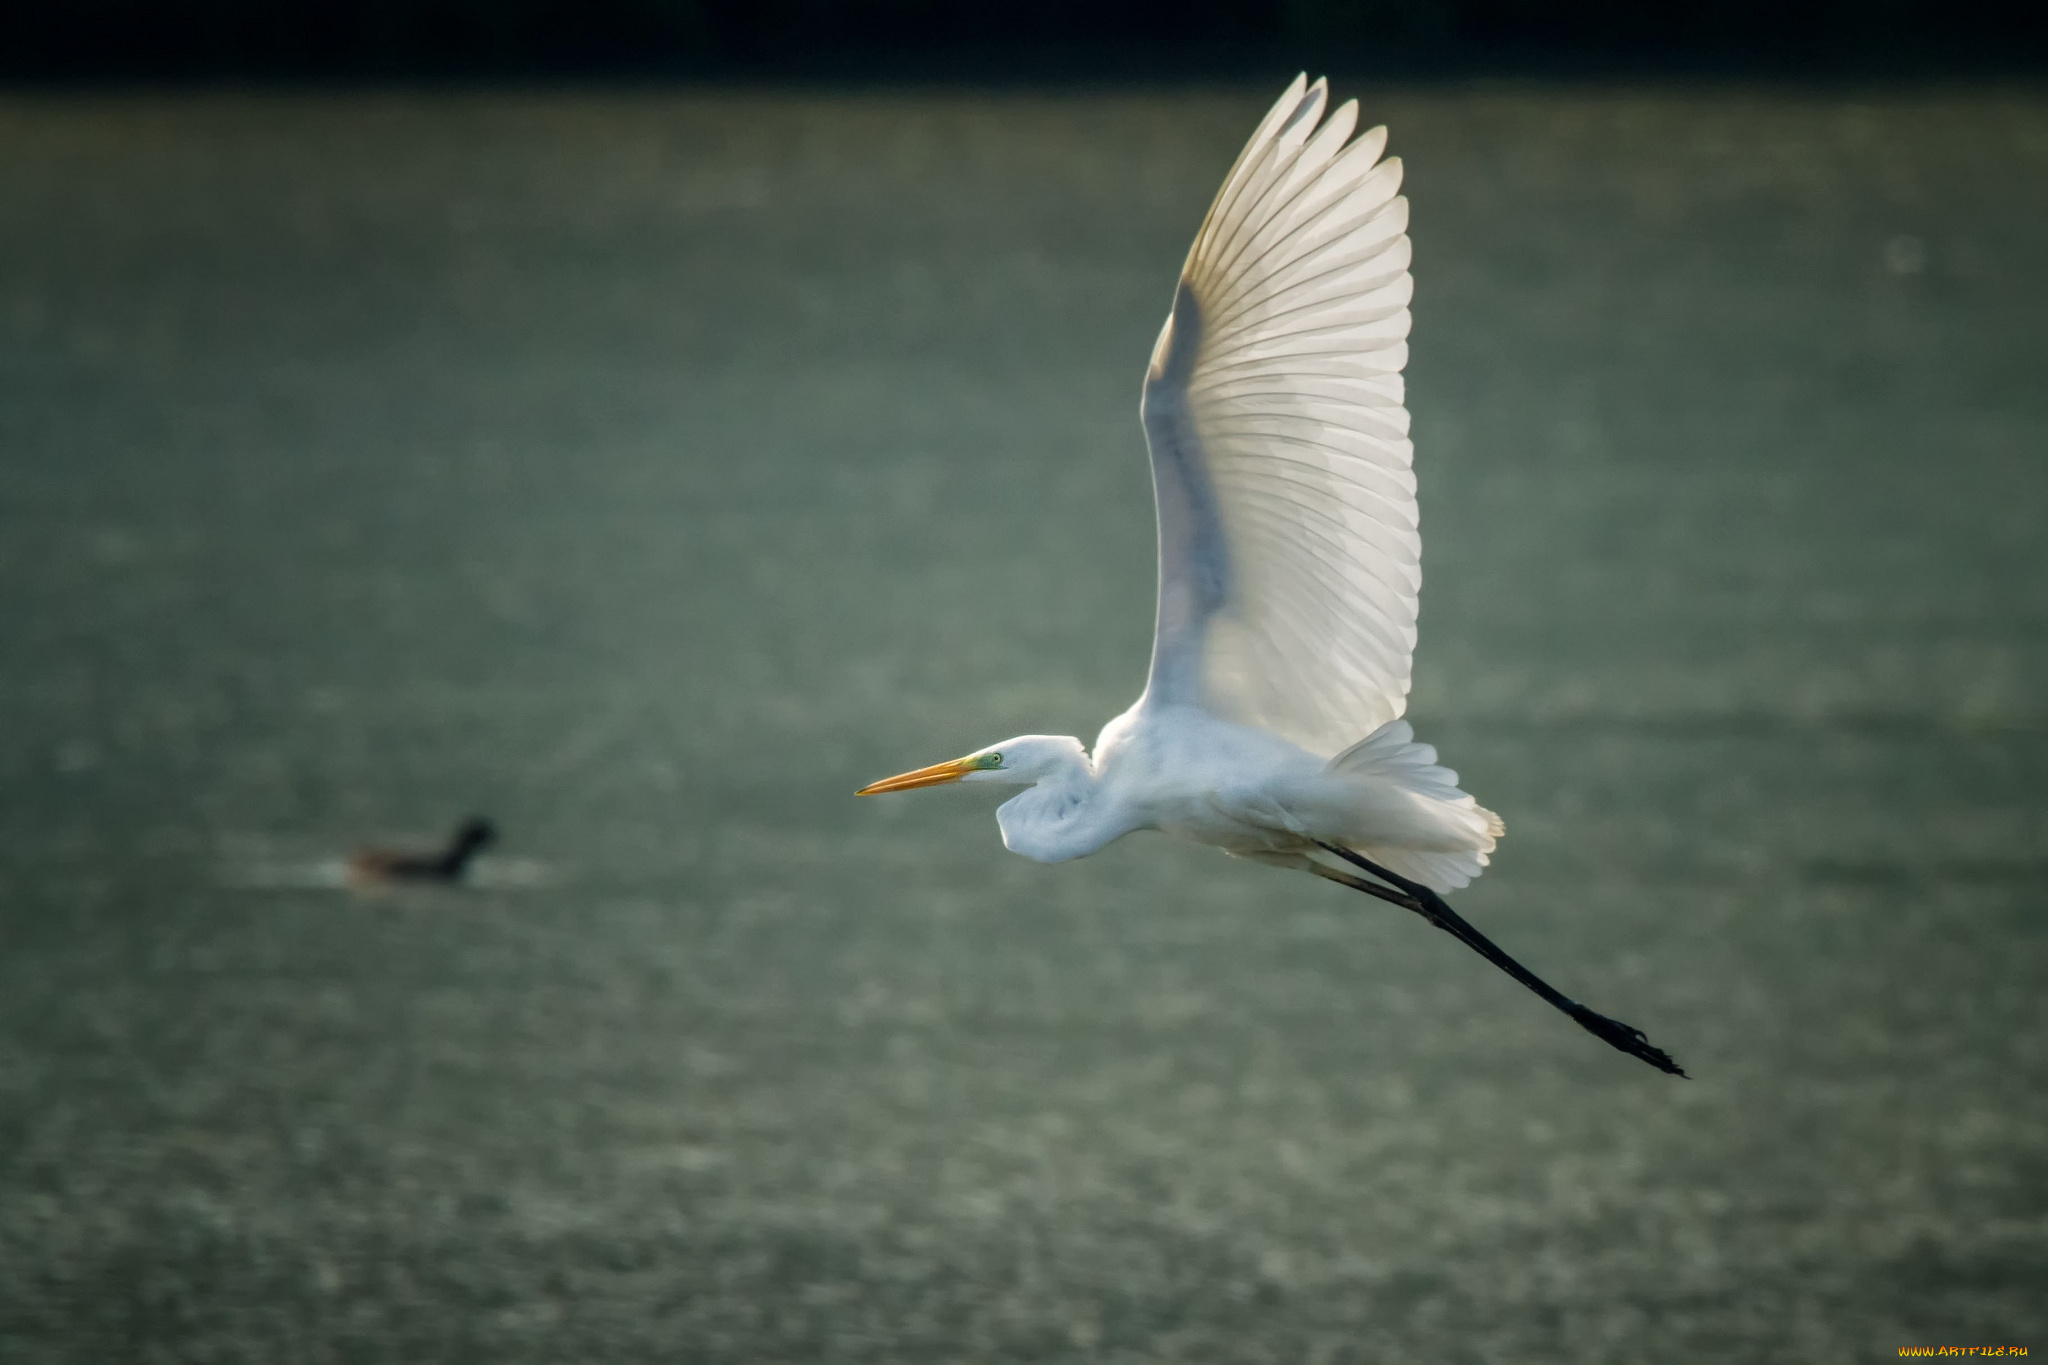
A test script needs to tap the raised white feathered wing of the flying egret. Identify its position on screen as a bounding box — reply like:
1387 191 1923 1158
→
1143 78 1421 757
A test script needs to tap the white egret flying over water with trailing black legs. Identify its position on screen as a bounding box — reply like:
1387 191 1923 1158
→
860 78 1686 1074
